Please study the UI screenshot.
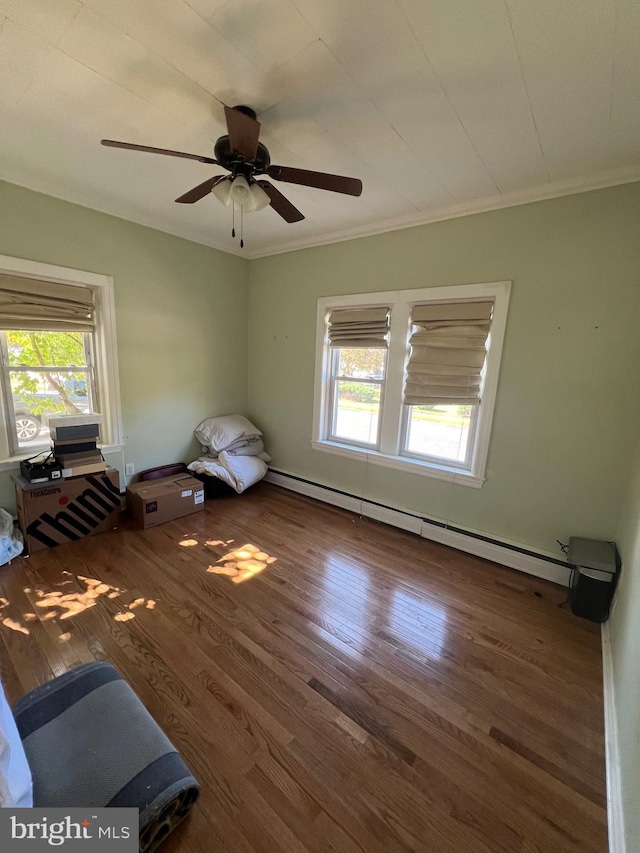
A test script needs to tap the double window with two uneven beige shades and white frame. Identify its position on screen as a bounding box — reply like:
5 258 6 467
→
313 282 511 488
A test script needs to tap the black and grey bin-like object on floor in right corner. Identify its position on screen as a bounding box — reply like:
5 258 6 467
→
567 536 621 622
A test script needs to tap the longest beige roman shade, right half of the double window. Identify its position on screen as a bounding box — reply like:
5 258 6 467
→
404 301 493 406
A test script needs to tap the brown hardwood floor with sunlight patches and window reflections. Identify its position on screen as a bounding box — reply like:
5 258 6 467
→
0 483 607 853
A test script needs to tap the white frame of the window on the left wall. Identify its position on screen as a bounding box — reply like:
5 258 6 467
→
0 255 124 471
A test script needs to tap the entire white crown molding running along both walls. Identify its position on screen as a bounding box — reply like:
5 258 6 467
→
0 166 640 261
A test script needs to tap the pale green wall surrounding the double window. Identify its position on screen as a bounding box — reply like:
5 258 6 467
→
249 184 640 556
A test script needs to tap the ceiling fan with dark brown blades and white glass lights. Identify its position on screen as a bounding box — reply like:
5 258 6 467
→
101 105 362 245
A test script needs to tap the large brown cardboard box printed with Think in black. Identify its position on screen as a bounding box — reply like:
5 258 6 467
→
14 468 121 554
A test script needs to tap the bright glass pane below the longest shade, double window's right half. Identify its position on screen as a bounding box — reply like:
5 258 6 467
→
406 406 472 462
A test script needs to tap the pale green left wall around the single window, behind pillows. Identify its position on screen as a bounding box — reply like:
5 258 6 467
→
0 182 248 511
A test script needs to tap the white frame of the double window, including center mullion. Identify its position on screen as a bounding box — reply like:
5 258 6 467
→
311 281 511 489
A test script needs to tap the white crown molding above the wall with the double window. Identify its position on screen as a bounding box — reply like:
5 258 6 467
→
247 166 640 260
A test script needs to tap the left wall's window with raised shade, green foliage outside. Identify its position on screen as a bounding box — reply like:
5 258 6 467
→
0 256 122 465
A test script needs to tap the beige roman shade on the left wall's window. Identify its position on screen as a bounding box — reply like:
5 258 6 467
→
0 275 94 332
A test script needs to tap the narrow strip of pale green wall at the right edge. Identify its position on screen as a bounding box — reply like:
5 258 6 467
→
609 445 640 853
